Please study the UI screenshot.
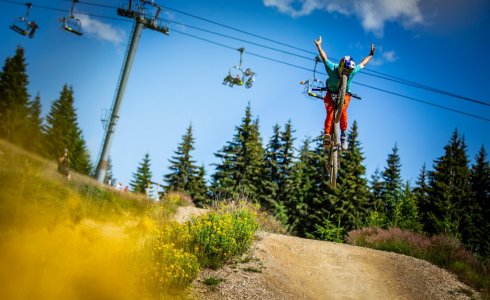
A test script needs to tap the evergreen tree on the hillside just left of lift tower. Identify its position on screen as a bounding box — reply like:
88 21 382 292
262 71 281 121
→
43 84 92 175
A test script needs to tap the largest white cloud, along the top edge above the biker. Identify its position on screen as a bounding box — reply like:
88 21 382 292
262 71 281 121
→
263 0 424 37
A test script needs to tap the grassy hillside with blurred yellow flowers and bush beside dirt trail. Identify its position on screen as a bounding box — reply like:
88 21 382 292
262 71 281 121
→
0 141 257 299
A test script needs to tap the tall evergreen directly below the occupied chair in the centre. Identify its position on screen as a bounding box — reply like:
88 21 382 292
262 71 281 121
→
212 103 268 202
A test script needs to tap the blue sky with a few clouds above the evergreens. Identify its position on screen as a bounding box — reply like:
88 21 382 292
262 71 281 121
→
0 0 490 185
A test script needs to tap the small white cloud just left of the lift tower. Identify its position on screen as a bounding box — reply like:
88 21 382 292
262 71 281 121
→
76 15 126 45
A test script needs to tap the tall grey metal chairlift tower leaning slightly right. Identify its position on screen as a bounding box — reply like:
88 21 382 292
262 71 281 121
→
95 0 169 182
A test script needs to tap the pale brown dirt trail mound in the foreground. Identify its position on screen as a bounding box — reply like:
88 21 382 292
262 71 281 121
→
179 208 478 300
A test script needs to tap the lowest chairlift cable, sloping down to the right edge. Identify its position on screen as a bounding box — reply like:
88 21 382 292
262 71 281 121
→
0 0 490 122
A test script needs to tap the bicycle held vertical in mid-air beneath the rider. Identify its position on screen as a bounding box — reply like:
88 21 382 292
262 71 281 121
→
311 75 361 189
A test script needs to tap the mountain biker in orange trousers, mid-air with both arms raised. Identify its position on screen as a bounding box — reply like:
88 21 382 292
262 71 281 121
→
314 36 375 150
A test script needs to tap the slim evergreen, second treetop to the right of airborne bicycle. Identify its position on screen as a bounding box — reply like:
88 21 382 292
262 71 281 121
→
381 144 402 223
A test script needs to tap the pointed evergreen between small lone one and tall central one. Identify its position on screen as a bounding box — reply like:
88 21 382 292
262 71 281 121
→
163 125 204 197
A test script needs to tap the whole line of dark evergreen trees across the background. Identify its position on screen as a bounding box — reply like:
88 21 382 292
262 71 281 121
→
0 47 490 259
